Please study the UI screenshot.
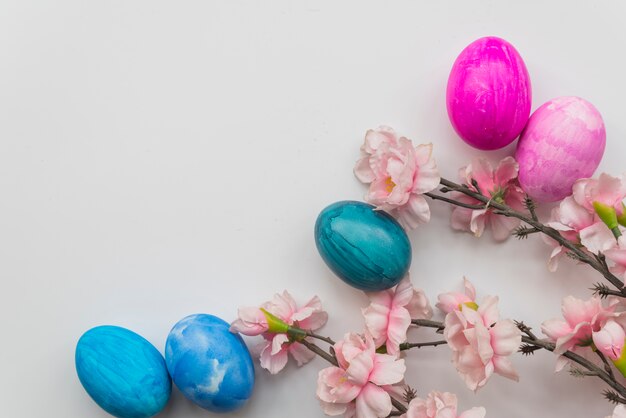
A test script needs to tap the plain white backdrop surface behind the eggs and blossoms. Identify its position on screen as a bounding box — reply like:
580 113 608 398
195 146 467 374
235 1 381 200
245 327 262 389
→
0 0 626 418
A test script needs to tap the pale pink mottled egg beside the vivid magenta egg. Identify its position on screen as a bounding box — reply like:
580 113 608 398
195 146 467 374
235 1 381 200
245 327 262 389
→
515 97 606 202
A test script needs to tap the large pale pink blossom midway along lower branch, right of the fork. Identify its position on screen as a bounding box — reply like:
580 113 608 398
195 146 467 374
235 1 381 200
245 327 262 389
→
436 284 522 391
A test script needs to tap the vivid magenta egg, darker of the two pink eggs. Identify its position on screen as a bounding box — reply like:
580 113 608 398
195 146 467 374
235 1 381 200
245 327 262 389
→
446 36 532 150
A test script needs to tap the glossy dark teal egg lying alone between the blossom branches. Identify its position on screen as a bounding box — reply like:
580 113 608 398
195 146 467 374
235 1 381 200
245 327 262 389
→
315 201 411 291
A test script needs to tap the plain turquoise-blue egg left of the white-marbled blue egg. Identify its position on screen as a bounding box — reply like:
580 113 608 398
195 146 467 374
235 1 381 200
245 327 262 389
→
76 325 172 418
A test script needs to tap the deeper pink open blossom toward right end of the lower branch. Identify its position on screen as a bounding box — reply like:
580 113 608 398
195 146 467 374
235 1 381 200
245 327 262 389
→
541 296 621 354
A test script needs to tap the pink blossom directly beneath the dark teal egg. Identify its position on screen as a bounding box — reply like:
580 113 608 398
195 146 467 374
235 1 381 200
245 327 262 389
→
363 275 433 355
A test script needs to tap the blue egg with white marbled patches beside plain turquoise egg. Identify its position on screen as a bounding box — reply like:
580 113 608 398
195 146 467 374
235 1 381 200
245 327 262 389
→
165 314 254 412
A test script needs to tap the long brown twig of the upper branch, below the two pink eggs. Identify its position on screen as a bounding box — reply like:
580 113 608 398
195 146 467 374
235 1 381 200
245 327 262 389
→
426 178 626 297
